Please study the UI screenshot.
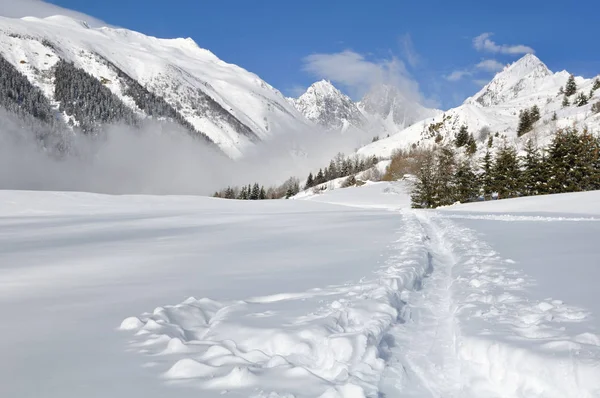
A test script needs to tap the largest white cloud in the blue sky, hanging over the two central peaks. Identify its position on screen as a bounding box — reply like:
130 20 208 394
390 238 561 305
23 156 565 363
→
303 50 424 103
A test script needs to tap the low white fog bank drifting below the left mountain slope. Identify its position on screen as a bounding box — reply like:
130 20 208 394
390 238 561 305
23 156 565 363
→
0 112 370 195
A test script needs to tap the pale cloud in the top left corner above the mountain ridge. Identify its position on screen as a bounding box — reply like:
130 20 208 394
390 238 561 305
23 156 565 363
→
0 0 107 27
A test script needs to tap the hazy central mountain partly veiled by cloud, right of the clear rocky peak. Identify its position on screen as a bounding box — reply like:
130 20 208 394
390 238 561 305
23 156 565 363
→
359 84 441 133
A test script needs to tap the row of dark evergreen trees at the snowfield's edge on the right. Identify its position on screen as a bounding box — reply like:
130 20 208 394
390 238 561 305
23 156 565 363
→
411 128 600 208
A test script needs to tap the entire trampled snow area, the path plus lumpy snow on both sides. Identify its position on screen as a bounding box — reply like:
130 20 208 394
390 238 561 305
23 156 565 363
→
119 210 600 398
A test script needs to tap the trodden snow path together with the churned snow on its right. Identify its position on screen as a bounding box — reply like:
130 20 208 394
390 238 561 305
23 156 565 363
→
381 213 600 398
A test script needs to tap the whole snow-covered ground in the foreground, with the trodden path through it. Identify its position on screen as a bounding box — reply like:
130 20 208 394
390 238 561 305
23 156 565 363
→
0 187 600 398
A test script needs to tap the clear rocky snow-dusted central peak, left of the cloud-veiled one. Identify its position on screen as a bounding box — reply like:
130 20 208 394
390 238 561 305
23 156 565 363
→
291 80 367 130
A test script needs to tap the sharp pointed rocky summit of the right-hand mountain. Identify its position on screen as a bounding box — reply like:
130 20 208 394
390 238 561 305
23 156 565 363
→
465 54 552 106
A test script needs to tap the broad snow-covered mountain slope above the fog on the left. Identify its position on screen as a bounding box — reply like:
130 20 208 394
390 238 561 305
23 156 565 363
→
0 16 312 158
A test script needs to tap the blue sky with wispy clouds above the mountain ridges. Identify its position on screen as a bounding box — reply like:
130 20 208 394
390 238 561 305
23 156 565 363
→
35 0 600 108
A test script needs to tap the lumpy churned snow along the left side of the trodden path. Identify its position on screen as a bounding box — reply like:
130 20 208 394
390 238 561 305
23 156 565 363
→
120 213 430 397
